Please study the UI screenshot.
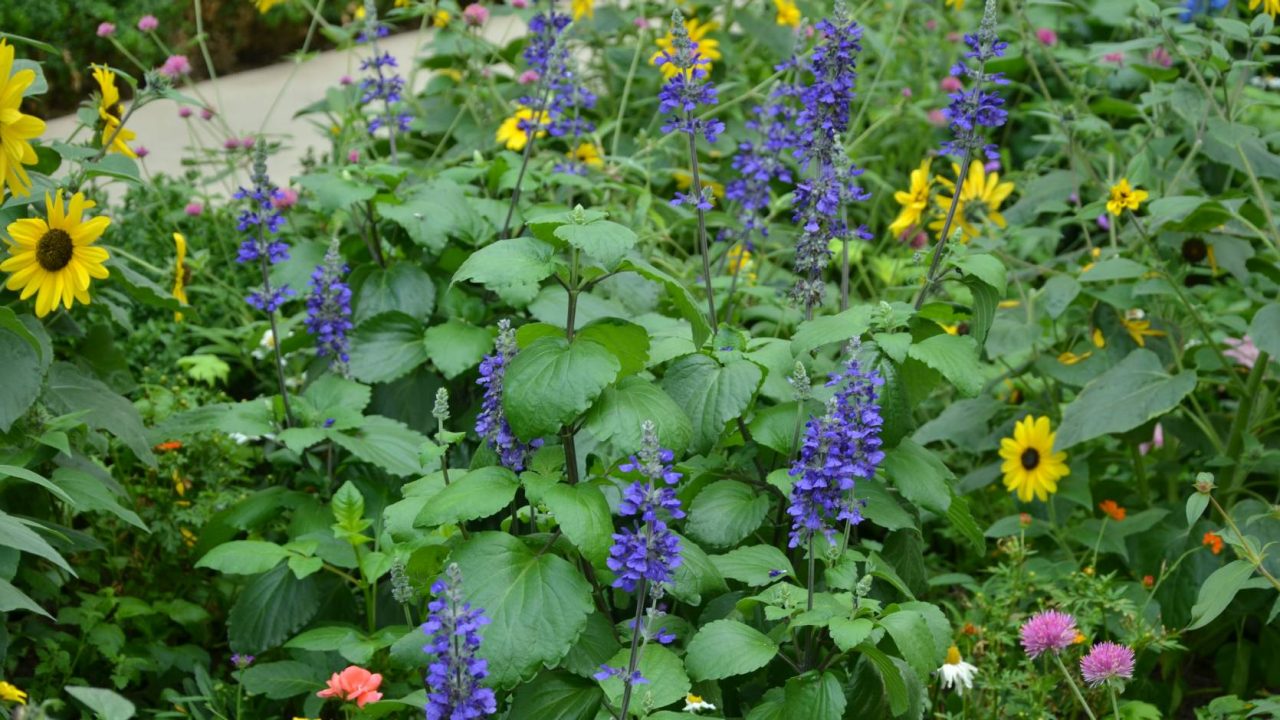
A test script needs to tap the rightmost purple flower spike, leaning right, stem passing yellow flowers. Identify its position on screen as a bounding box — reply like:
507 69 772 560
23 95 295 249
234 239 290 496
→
915 0 1009 310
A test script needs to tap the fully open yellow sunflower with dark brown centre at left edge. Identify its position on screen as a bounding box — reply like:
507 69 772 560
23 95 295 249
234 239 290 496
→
0 190 111 318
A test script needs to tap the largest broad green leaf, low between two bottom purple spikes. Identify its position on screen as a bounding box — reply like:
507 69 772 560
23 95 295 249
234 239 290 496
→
452 533 594 689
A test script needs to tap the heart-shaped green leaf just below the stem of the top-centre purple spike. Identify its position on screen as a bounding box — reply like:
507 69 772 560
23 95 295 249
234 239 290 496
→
662 354 764 452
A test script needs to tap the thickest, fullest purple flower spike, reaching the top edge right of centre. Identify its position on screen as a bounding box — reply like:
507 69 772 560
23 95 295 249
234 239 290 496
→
791 0 872 319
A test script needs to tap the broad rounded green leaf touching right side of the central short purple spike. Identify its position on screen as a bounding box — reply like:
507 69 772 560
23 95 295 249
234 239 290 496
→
503 337 621 439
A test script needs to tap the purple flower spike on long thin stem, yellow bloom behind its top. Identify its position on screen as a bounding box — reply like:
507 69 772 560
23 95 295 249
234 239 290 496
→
655 10 724 328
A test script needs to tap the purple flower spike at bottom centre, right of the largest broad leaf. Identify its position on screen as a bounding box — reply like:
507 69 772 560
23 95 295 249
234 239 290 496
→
595 420 685 717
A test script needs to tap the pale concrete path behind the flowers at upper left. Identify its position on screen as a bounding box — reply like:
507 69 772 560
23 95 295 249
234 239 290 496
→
44 15 525 192
